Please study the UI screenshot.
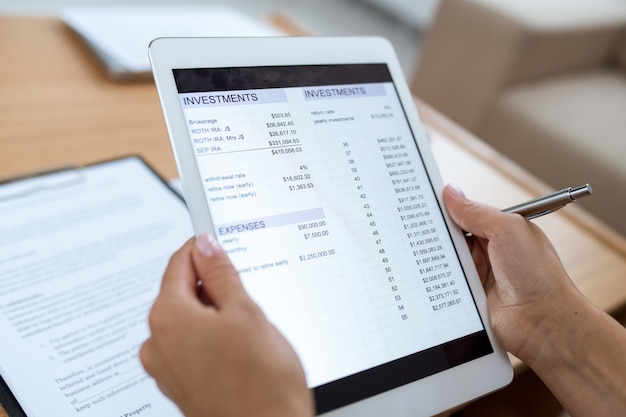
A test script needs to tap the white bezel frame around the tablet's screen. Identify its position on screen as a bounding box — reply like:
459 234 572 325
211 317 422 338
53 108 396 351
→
149 37 513 417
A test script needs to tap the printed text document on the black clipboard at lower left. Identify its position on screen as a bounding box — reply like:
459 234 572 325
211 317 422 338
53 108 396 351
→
0 157 193 417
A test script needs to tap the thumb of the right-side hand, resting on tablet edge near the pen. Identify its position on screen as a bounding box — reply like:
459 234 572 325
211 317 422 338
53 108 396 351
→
443 184 521 240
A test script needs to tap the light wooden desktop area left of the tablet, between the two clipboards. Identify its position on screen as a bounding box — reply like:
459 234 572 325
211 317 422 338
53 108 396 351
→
0 17 177 182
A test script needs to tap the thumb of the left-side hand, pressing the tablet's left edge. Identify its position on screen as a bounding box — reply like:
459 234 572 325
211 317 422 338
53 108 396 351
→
191 234 248 310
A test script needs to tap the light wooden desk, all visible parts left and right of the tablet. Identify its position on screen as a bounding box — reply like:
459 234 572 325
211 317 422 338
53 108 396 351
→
0 17 626 417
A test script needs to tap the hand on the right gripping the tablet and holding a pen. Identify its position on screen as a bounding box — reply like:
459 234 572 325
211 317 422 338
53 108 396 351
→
443 185 585 364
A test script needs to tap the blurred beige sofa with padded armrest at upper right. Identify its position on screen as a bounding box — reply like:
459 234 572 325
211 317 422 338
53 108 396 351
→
411 0 626 235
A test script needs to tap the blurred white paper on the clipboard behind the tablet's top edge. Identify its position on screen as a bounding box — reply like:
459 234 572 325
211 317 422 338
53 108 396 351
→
61 6 284 79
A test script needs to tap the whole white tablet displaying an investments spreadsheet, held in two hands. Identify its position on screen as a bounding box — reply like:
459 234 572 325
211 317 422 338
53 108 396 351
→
150 37 512 417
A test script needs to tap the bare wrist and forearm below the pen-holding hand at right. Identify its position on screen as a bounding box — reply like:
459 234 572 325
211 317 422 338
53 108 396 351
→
520 296 626 416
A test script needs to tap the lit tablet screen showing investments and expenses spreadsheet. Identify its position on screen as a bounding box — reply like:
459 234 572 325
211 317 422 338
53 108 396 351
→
174 64 493 412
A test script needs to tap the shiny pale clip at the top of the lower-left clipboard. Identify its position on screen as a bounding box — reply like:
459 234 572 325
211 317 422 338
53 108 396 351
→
0 165 85 203
